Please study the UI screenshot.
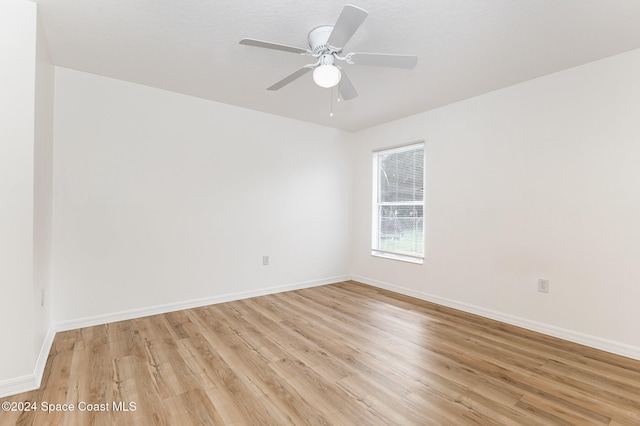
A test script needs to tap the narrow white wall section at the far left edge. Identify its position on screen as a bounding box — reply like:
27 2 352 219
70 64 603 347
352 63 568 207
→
0 0 36 382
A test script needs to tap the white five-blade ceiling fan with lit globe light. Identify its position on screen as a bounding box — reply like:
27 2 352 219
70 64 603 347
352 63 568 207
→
240 4 418 100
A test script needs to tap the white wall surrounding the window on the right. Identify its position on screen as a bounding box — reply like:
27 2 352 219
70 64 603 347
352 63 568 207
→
352 51 640 358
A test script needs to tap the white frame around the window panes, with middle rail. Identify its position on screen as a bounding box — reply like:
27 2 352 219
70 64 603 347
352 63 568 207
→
371 140 426 264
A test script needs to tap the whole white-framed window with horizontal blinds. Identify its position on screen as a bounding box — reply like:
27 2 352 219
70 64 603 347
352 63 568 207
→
371 142 424 263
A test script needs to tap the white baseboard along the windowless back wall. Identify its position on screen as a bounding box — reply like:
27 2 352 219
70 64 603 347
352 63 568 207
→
54 275 350 331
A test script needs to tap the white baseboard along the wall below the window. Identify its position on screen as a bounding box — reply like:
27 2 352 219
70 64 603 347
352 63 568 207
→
351 275 640 361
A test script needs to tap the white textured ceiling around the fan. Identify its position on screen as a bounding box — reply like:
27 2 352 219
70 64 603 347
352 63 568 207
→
38 0 640 131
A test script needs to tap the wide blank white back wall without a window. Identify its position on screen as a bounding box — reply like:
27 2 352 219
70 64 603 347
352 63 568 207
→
53 68 351 327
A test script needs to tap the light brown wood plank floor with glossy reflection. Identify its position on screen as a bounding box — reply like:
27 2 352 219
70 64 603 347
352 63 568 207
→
0 282 640 426
